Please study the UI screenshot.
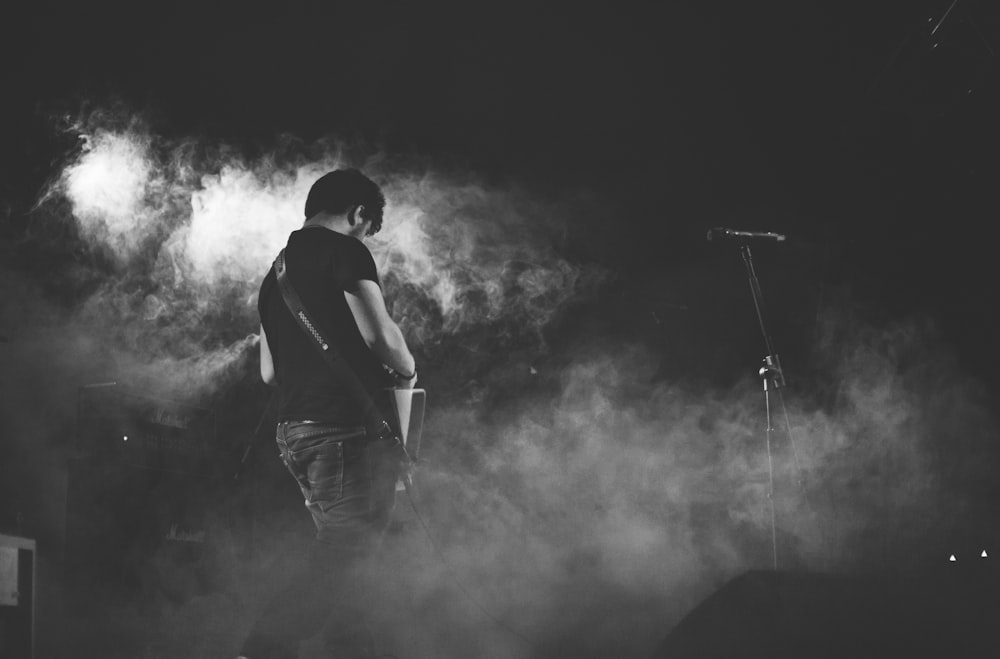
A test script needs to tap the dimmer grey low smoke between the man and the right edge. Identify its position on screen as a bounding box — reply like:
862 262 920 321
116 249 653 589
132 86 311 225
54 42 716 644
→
364 316 997 657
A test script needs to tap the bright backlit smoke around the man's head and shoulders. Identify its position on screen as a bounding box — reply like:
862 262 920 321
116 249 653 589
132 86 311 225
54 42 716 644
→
35 114 605 402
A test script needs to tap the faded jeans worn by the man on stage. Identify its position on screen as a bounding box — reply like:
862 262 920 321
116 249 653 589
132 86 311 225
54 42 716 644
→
241 421 398 659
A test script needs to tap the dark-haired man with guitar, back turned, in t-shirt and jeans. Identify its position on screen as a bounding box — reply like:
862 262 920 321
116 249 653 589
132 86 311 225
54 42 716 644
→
241 169 417 659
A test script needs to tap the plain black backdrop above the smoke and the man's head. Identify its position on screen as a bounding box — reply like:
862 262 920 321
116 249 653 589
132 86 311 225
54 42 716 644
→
2 1 1000 381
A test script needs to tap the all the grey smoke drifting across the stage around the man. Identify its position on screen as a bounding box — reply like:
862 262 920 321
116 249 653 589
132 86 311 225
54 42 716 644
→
3 108 997 658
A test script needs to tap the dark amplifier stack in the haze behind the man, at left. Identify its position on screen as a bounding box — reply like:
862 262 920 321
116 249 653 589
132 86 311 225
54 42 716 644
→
64 382 223 599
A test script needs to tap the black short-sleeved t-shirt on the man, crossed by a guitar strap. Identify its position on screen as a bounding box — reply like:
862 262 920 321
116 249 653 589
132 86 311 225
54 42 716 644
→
257 227 391 426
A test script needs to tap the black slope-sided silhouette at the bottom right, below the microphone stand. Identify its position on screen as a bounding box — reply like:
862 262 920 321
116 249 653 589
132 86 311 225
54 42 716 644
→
651 571 1000 659
